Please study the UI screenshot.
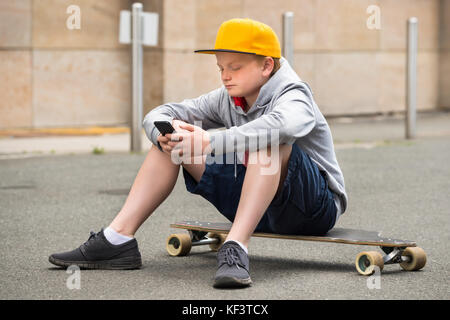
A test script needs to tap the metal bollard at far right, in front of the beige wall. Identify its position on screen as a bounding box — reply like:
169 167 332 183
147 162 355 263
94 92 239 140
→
406 17 418 139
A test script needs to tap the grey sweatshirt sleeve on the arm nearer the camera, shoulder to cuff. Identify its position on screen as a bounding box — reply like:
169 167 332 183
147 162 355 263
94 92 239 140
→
210 89 316 155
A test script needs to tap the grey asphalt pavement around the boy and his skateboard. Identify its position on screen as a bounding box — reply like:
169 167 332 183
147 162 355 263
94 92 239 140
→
0 113 450 300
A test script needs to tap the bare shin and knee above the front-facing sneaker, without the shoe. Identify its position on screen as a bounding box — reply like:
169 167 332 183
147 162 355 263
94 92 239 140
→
227 144 292 247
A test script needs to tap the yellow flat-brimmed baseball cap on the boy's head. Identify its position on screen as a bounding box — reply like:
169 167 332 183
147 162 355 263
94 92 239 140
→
194 18 281 58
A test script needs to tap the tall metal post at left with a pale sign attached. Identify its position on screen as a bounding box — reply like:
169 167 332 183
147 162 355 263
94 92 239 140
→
130 3 143 152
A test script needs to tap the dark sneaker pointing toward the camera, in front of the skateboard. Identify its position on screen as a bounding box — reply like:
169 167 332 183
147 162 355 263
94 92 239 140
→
214 241 252 288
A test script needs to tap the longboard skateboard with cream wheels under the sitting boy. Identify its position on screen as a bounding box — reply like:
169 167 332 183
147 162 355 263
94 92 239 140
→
166 221 427 275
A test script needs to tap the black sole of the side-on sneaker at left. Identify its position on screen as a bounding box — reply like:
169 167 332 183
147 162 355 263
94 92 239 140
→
48 256 142 270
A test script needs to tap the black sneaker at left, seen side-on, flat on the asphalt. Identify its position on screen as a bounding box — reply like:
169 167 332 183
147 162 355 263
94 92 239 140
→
48 229 142 270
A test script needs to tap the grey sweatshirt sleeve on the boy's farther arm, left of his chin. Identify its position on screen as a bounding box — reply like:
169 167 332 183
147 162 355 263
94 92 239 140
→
142 88 223 151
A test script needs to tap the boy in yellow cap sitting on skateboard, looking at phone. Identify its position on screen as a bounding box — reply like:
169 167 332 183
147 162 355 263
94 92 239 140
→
49 19 347 287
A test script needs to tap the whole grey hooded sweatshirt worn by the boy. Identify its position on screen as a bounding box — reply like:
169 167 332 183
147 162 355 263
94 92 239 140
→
143 57 348 221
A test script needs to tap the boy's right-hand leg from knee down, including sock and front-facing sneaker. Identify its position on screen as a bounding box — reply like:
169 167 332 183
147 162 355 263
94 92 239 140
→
214 145 292 288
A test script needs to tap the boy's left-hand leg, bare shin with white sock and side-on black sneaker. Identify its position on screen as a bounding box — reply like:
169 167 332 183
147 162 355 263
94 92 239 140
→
49 147 205 269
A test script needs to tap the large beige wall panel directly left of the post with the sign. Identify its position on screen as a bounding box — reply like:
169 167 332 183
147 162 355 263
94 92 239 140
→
33 50 130 127
